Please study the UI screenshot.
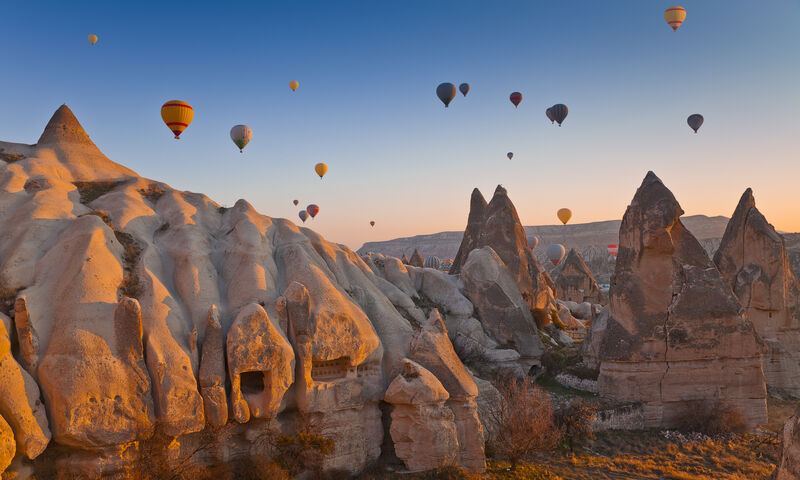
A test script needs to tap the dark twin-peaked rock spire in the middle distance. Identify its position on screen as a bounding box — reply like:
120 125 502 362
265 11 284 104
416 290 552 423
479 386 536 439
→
450 185 555 312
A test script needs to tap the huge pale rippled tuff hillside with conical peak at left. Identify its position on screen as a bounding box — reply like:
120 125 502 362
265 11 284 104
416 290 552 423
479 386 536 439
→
0 106 484 477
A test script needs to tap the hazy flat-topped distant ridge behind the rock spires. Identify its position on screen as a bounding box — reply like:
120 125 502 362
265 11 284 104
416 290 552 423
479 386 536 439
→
358 215 800 283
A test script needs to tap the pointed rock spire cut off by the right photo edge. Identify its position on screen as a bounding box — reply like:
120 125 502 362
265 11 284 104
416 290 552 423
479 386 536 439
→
714 188 800 396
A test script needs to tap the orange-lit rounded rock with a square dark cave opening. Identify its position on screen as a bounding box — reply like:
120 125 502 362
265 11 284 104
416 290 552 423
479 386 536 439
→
227 303 294 423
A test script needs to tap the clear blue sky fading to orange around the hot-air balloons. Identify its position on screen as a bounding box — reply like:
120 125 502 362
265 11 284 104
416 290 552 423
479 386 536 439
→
0 0 800 248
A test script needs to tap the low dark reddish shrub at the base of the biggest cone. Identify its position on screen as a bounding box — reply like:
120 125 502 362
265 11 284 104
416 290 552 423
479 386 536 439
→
676 400 747 436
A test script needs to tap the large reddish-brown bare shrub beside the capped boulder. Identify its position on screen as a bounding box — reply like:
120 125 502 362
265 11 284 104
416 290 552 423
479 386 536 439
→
486 378 561 469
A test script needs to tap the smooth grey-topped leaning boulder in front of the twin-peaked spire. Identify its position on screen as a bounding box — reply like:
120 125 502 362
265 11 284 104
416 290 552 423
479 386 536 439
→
460 247 544 371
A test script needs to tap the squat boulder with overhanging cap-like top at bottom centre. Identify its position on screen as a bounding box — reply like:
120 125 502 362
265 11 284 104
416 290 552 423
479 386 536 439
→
384 360 458 472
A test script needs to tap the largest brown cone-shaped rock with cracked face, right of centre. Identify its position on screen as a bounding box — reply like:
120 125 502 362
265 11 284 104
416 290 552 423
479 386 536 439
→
592 172 766 427
